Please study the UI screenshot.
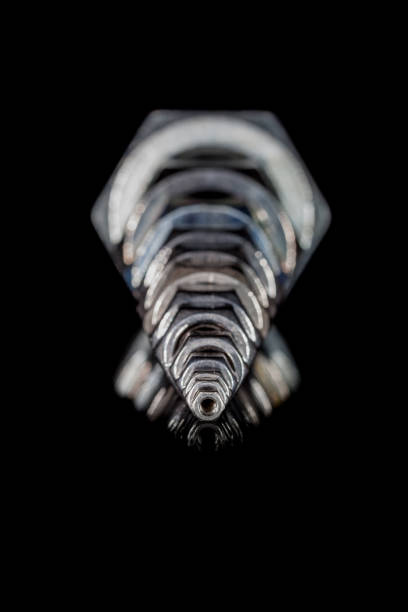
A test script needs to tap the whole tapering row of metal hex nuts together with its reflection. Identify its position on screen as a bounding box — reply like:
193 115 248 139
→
92 111 330 447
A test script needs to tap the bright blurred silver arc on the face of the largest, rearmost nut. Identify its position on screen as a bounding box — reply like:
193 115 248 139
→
108 114 315 248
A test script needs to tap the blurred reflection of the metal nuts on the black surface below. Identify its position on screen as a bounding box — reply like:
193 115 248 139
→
116 327 300 450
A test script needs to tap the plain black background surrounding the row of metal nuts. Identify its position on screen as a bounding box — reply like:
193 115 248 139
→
3 8 396 596
